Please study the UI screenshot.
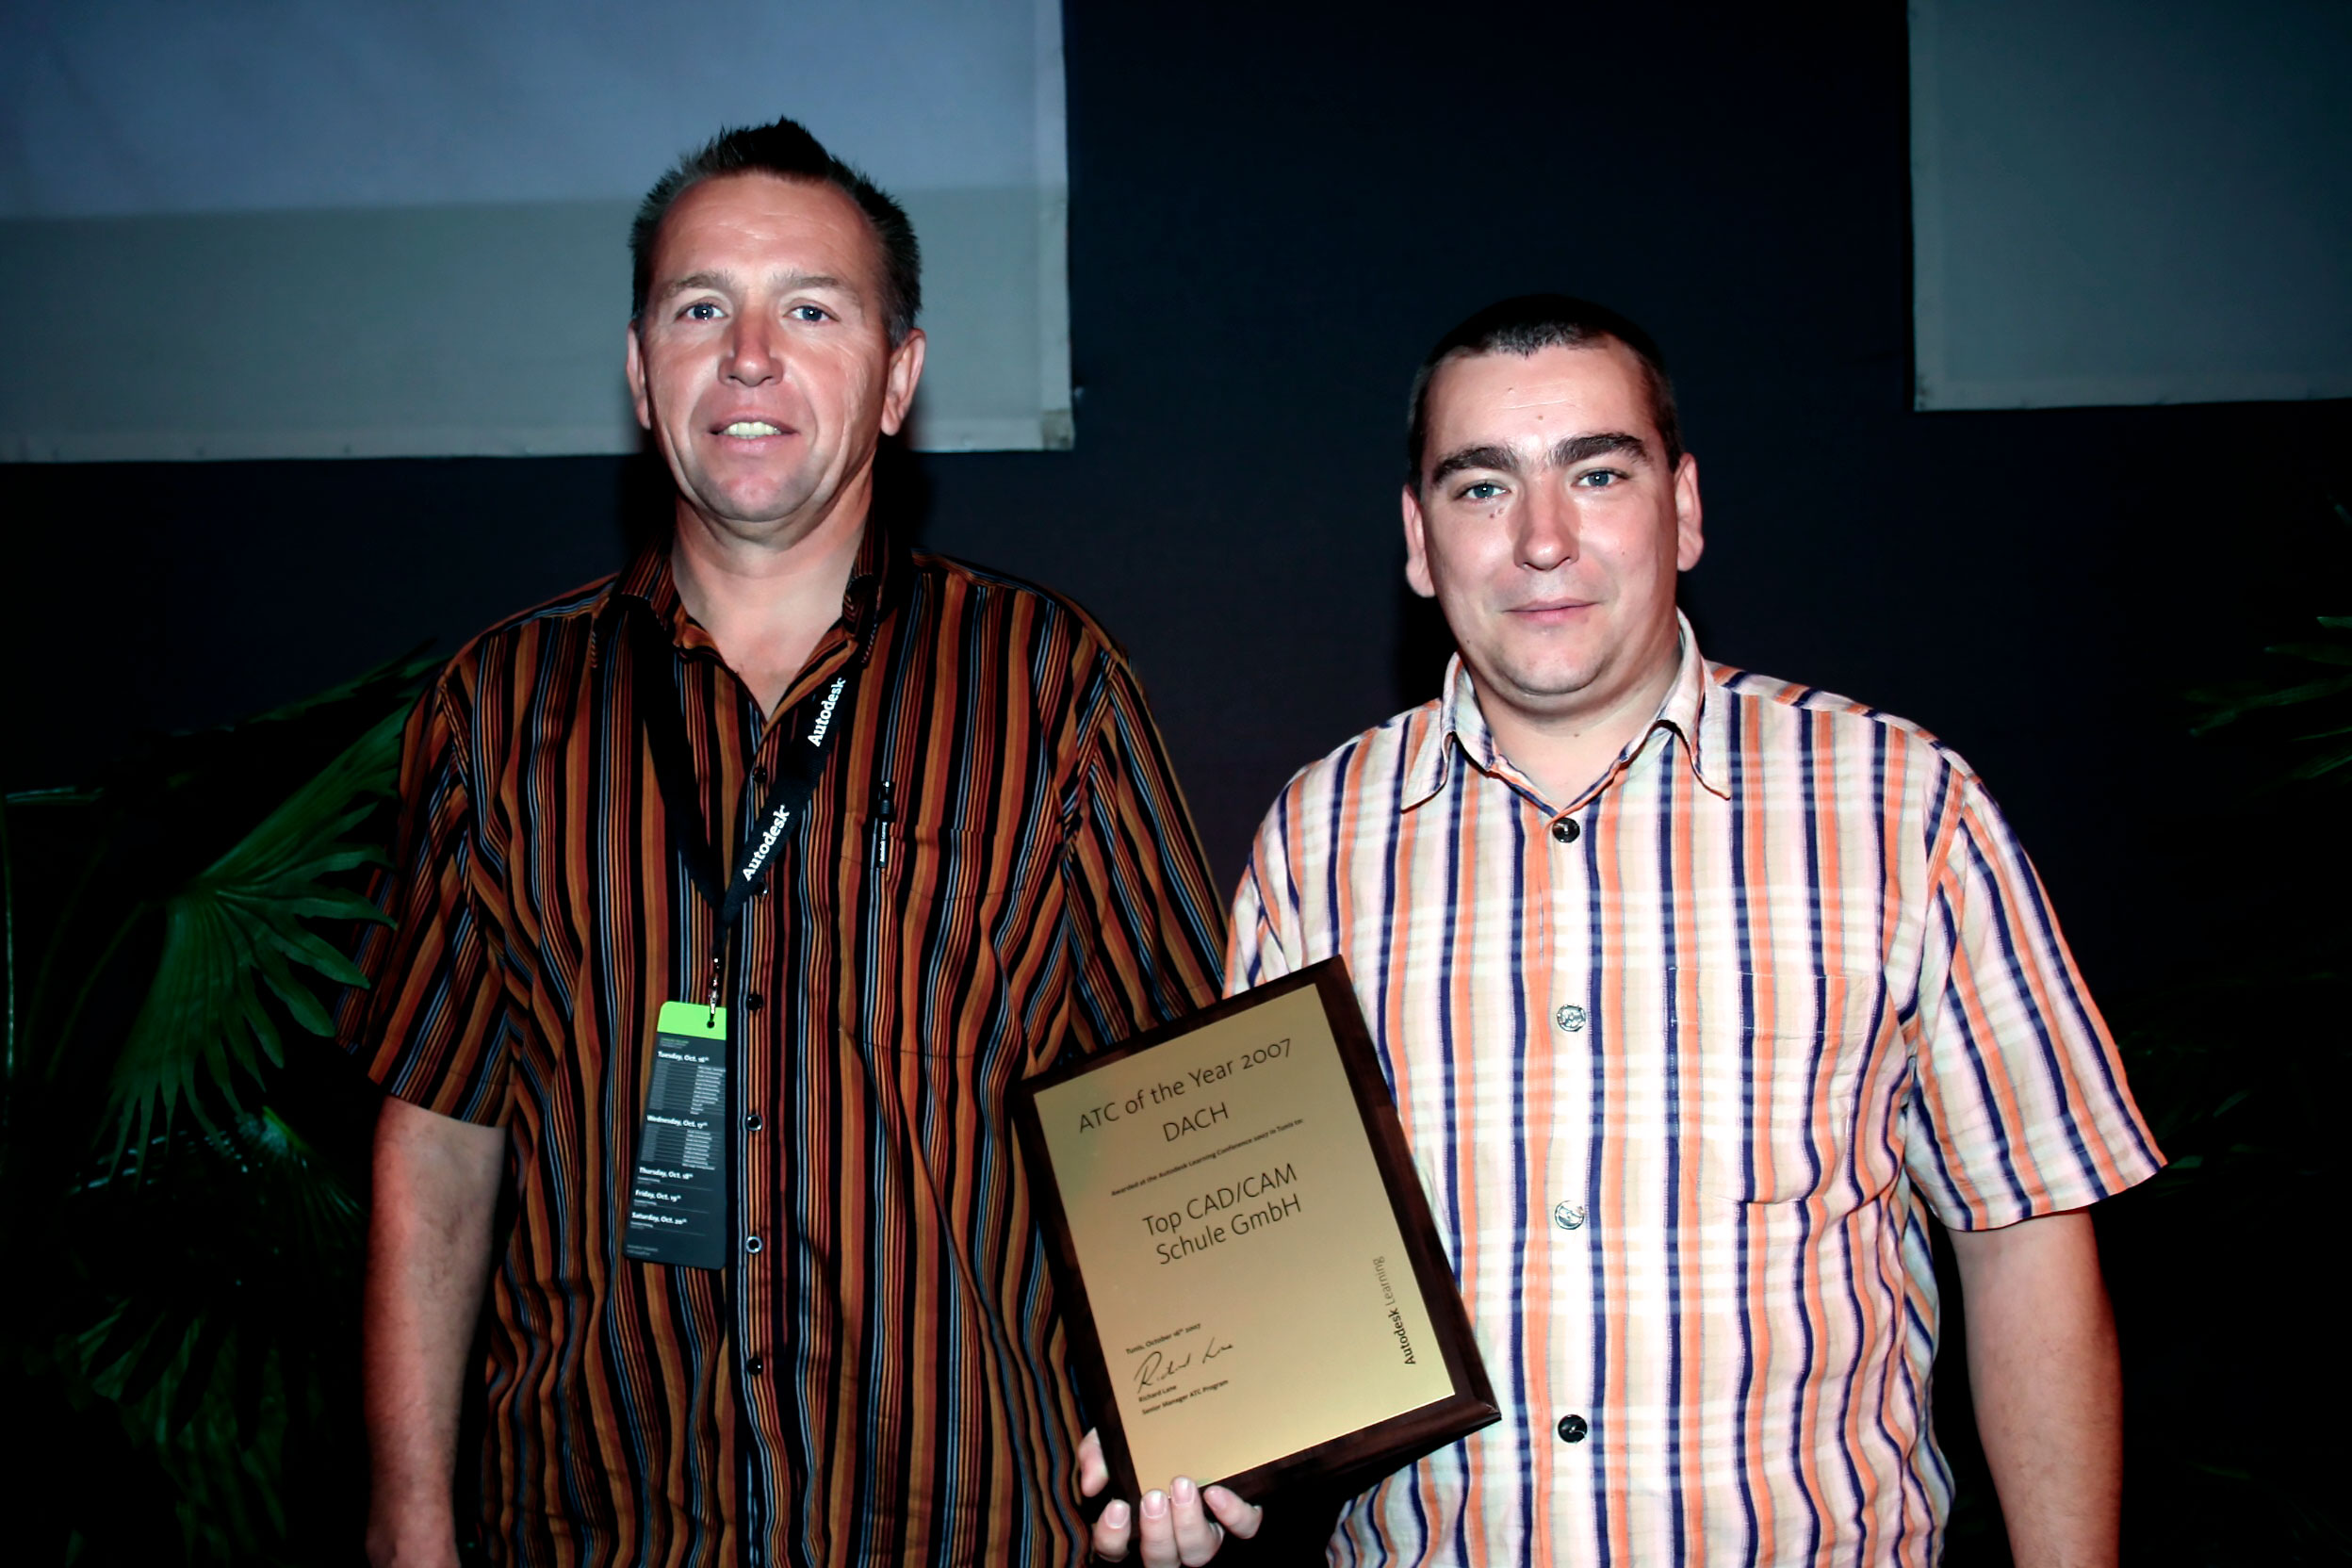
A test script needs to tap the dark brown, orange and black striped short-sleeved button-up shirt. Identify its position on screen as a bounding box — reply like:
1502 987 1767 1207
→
346 536 1223 1566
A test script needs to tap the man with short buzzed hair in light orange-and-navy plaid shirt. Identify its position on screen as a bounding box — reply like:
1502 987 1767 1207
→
1228 296 2162 1566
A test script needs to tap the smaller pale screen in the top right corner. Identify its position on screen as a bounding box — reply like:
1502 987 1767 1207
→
1910 0 2352 409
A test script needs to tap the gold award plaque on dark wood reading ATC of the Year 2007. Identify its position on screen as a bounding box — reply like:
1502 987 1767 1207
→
1014 959 1498 1500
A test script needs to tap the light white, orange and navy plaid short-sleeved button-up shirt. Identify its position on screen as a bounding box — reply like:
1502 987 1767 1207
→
1228 623 2162 1566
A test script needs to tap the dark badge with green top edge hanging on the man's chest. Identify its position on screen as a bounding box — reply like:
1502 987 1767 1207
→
621 1002 729 1269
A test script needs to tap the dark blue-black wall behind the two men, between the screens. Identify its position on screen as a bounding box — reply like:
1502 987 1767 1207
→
0 5 2352 1005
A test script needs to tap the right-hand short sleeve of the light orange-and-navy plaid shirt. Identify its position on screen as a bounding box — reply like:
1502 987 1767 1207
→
1905 778 2164 1230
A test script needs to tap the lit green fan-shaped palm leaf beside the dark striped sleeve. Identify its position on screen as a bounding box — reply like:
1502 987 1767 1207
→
108 712 404 1161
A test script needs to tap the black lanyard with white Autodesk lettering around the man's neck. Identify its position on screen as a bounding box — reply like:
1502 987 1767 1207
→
628 607 863 944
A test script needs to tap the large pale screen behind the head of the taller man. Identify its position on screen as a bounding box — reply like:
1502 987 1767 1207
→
0 0 1072 463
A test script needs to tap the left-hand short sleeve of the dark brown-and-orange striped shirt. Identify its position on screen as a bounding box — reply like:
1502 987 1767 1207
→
338 675 517 1126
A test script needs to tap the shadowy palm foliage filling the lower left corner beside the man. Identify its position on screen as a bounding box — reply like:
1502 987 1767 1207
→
0 661 426 1563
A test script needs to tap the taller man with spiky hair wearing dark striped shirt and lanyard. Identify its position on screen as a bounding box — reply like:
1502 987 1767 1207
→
343 120 1247 1568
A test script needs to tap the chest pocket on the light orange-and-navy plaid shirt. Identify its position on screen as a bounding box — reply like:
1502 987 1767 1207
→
1673 971 1886 1216
